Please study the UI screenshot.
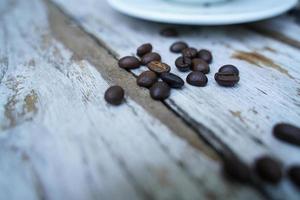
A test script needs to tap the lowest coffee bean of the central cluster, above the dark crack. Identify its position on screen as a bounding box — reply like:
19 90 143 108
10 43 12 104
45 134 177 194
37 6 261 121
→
150 81 171 100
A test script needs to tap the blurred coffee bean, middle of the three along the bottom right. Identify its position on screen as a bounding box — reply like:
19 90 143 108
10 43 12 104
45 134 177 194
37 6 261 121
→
255 156 282 184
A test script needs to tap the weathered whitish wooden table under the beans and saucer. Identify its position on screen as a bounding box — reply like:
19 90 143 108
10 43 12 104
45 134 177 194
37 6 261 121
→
0 0 300 200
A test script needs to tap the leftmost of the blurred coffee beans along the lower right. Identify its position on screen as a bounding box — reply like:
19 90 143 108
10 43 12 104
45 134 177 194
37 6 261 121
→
223 156 252 183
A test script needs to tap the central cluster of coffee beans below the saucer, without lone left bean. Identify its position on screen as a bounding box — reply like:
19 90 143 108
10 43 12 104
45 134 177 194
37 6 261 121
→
104 41 240 105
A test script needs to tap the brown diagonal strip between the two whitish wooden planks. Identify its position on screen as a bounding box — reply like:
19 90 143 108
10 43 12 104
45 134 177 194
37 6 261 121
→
45 0 220 160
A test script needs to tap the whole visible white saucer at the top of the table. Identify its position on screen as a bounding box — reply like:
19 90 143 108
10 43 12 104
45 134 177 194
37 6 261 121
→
108 0 297 25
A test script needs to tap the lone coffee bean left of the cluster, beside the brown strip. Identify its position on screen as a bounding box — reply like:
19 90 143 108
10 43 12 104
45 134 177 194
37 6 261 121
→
104 85 124 105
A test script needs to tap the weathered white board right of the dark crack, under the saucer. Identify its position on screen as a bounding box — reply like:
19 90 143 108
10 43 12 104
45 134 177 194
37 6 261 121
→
54 0 300 199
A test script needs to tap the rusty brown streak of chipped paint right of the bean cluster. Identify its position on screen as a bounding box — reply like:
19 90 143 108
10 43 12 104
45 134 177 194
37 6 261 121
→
232 51 294 79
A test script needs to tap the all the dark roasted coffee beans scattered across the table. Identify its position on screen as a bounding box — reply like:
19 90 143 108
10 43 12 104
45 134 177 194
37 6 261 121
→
105 39 300 187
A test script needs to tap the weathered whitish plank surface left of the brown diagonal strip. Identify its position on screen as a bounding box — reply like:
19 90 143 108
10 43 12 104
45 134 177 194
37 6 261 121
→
0 0 262 200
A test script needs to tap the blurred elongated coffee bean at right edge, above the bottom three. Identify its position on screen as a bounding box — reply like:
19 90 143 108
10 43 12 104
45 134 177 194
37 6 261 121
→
273 123 300 146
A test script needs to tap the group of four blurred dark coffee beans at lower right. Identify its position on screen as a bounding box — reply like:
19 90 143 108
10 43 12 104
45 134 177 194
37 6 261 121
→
223 123 300 187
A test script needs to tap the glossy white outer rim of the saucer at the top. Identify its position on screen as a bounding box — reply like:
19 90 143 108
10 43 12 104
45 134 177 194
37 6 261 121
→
108 0 298 25
